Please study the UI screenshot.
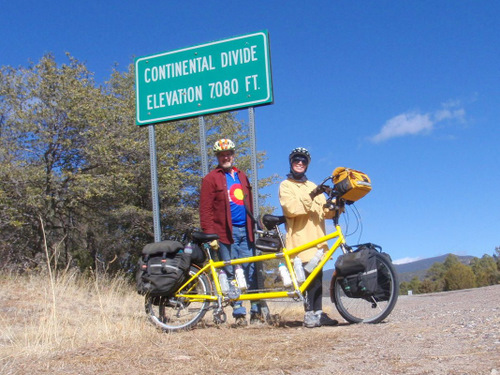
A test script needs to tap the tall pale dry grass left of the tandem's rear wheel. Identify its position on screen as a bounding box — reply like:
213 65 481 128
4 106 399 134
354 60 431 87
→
0 273 146 358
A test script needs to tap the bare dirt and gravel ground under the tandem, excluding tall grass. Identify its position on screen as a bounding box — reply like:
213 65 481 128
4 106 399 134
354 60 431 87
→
0 285 500 375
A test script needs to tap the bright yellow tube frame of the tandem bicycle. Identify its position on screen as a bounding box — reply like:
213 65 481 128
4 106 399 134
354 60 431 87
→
175 220 346 301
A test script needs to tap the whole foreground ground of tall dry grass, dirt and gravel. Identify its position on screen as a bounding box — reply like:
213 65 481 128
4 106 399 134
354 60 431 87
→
0 273 500 375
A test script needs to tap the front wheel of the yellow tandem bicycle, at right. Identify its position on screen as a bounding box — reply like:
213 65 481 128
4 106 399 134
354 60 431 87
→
330 254 399 324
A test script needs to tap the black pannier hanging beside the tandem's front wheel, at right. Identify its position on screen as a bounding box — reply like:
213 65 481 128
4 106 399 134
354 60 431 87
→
335 243 391 302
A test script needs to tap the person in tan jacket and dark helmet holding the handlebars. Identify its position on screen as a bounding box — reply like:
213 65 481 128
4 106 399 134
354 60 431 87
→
279 147 338 328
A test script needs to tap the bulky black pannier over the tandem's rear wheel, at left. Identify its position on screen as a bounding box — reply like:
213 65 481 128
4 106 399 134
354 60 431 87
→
136 241 191 297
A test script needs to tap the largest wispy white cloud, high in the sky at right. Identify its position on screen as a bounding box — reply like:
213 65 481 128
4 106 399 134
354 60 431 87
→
371 103 465 143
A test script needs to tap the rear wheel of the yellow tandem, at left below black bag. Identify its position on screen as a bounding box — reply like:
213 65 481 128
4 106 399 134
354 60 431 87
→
145 266 212 332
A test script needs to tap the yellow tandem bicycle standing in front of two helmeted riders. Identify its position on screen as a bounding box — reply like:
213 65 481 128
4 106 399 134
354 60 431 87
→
145 176 399 332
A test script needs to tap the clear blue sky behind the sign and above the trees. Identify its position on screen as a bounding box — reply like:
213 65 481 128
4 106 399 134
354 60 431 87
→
0 0 500 260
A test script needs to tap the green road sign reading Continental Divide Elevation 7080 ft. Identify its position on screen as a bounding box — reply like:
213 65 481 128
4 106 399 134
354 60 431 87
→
135 31 273 125
